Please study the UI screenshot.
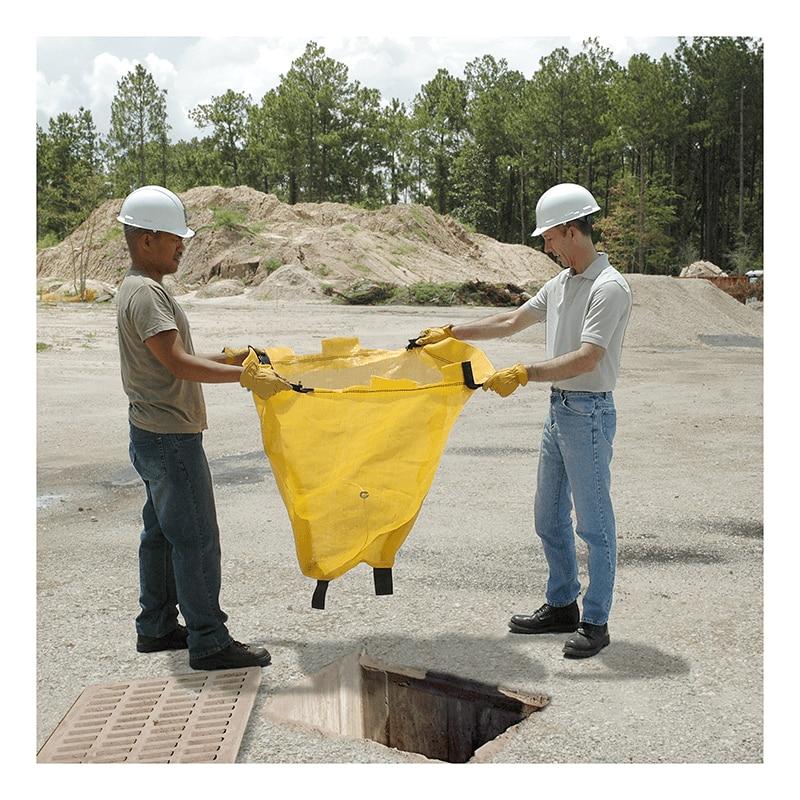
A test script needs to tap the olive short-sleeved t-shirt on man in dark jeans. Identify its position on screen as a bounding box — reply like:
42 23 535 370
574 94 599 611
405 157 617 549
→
117 267 208 433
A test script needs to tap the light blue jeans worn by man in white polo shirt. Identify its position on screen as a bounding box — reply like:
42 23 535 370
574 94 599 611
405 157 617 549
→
534 389 617 625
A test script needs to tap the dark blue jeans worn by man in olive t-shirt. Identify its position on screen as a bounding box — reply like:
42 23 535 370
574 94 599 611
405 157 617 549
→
130 425 232 657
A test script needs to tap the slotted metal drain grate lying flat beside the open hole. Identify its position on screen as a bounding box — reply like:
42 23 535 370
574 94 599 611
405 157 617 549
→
37 667 261 764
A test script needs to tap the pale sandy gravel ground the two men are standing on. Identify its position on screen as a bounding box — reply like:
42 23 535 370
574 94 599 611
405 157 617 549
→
37 298 763 762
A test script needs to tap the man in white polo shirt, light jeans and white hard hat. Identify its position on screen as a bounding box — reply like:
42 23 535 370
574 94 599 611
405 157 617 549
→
416 183 631 658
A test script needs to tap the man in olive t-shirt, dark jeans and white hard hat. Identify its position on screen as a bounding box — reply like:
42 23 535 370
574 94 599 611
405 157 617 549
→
111 186 291 670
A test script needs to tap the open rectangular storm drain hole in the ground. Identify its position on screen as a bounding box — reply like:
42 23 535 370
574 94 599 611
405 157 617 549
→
264 653 549 763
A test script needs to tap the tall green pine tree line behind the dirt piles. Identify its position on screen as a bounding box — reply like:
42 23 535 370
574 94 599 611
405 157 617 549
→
36 37 763 274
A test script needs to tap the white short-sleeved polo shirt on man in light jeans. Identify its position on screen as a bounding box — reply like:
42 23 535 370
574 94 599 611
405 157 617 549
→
522 253 632 392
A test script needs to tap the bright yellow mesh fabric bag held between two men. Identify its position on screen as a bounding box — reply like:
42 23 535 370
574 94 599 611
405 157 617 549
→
245 338 493 580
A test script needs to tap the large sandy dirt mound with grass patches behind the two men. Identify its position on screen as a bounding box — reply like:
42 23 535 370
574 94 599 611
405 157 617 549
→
37 186 559 289
